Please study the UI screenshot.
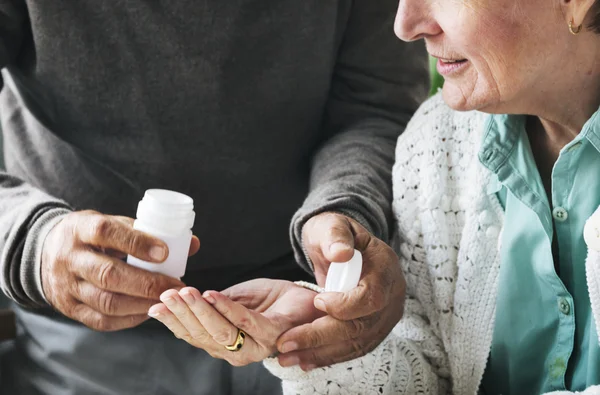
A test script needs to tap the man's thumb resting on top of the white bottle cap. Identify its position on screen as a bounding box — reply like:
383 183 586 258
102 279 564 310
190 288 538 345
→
303 213 354 262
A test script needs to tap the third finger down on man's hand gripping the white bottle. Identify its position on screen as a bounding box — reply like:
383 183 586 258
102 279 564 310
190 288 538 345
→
74 281 154 317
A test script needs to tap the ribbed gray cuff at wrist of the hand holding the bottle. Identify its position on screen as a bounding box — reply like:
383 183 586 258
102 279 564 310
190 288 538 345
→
19 208 71 308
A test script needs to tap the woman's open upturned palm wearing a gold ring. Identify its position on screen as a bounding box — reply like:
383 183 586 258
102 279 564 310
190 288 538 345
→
148 279 324 366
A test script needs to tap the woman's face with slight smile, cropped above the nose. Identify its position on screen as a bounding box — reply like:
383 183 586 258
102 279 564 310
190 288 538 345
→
395 0 570 112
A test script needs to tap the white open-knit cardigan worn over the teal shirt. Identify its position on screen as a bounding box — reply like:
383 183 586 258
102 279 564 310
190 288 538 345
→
265 95 600 395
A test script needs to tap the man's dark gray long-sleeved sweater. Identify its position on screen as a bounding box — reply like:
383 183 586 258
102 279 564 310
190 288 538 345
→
0 0 427 307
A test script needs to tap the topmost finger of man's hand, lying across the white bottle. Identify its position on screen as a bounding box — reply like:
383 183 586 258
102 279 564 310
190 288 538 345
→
75 213 169 263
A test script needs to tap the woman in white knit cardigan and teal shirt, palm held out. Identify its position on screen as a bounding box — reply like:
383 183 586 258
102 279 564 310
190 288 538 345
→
151 0 600 395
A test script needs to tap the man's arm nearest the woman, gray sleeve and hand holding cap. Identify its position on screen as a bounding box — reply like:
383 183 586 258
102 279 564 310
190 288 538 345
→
278 0 427 367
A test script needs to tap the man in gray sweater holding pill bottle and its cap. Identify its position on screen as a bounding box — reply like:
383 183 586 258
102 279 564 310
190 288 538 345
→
0 0 426 395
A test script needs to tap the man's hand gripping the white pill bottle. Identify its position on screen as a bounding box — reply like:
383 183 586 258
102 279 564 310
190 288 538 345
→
41 211 200 331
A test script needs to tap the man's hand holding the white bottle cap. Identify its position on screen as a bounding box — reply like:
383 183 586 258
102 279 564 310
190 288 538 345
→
277 213 406 370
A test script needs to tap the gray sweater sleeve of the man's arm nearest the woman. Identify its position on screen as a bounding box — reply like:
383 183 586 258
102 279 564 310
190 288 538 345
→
290 0 428 269
